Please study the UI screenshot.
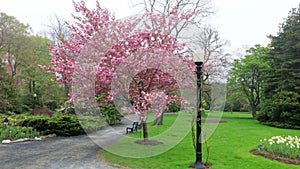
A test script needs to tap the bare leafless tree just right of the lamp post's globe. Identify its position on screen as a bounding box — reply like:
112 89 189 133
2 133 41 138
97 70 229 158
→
192 25 230 108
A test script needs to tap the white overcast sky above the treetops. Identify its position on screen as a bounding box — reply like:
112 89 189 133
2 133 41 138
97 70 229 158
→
0 0 300 50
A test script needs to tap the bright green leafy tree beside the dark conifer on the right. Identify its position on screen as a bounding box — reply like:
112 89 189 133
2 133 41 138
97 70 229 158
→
229 45 269 117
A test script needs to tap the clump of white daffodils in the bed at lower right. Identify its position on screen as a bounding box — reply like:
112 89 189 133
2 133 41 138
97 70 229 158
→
258 136 300 161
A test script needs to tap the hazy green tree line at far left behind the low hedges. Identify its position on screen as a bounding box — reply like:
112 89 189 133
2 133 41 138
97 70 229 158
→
0 12 64 114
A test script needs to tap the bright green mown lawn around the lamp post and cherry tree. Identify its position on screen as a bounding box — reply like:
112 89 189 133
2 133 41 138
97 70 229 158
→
100 113 300 169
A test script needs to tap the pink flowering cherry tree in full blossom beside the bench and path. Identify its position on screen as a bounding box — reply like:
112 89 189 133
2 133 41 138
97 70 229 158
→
40 1 195 140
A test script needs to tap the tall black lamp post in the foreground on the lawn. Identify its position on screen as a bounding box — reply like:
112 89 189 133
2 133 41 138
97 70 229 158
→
194 56 206 169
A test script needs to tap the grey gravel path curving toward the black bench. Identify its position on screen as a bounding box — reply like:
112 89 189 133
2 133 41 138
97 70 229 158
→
0 116 137 169
